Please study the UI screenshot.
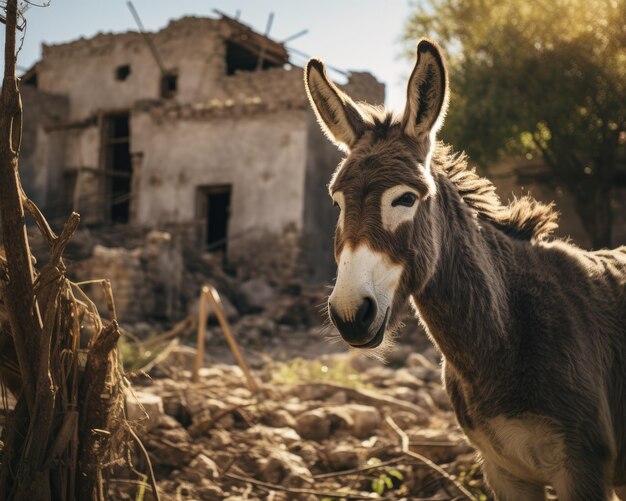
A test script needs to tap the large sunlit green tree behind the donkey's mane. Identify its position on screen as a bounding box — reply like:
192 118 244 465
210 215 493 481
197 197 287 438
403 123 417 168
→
404 0 626 248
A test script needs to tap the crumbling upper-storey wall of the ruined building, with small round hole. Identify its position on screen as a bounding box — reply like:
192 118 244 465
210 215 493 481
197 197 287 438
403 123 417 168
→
37 18 223 120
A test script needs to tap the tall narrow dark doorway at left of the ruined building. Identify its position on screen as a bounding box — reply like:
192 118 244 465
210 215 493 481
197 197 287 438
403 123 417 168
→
104 113 133 223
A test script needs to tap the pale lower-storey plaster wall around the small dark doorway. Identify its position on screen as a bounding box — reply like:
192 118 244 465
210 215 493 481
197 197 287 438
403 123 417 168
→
131 110 307 242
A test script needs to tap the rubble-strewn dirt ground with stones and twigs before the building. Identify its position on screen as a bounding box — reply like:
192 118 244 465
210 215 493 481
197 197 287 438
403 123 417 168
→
112 298 489 501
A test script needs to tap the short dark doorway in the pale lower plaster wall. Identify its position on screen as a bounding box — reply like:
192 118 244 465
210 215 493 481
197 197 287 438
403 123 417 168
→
199 185 232 253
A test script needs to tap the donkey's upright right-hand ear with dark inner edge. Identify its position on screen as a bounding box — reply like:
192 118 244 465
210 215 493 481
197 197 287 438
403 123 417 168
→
402 39 448 139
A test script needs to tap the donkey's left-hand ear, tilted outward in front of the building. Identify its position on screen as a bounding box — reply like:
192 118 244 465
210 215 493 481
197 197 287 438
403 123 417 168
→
304 59 367 149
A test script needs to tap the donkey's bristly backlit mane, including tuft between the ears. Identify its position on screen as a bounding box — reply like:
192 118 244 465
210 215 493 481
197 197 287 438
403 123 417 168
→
360 109 559 240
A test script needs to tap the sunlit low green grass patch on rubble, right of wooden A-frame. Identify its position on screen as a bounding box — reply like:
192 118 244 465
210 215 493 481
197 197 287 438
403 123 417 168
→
268 357 364 388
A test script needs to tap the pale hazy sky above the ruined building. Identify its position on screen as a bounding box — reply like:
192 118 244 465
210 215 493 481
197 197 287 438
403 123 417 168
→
0 0 412 111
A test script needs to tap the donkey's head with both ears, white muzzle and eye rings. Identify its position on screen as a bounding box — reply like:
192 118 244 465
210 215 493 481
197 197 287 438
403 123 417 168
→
305 40 447 348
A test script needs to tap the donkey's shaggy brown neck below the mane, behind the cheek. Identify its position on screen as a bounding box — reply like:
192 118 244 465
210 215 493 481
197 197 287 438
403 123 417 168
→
413 176 510 377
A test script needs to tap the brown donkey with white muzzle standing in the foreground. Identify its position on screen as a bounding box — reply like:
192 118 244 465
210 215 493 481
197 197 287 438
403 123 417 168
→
304 40 626 501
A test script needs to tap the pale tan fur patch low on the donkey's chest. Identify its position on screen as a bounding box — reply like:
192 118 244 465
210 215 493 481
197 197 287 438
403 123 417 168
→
465 415 565 483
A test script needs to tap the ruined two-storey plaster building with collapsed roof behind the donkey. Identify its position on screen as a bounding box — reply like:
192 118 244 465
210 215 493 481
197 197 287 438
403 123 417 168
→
20 16 384 279
